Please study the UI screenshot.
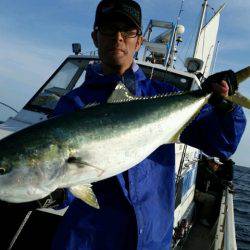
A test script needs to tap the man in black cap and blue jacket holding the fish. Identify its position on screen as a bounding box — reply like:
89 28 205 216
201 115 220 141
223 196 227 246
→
49 0 245 250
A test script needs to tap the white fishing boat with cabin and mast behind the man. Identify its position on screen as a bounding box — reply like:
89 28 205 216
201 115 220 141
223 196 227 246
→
0 0 237 250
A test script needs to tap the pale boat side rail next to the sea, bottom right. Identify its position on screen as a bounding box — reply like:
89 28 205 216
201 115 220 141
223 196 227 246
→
214 187 237 250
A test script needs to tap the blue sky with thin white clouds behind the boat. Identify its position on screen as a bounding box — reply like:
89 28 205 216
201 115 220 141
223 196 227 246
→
0 0 250 167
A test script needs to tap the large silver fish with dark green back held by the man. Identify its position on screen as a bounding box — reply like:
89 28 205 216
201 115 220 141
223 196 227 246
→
0 66 249 207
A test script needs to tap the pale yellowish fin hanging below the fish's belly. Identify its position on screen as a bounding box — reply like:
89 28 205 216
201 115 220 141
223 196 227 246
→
69 184 100 209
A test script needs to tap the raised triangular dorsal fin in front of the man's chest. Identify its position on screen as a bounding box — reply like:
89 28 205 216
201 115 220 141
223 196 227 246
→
107 82 137 103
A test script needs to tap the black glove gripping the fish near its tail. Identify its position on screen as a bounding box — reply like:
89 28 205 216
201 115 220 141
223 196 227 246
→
201 70 238 113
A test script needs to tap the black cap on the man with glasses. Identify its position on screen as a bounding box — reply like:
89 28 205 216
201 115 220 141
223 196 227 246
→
94 0 141 30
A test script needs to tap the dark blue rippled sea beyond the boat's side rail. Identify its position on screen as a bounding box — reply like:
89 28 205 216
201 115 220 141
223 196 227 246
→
234 166 250 250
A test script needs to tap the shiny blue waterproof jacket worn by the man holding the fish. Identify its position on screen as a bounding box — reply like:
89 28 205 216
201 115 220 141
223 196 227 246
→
53 64 246 250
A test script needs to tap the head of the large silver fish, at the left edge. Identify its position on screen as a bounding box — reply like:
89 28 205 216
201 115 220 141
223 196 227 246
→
0 152 56 203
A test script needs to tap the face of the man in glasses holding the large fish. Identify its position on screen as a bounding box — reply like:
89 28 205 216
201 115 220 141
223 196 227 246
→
92 21 142 67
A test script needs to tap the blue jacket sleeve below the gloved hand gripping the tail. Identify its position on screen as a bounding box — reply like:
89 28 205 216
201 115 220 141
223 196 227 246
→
180 104 246 158
